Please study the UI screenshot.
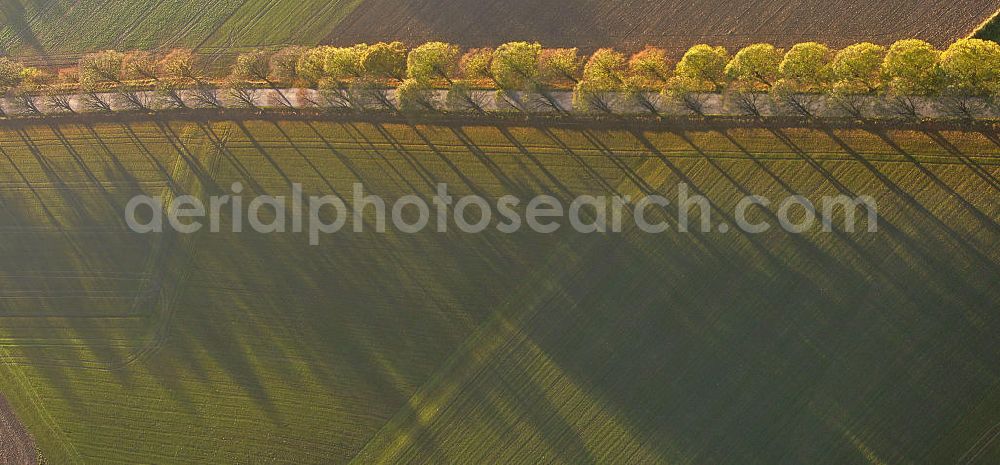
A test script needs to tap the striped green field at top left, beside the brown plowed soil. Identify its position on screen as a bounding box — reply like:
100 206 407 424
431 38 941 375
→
0 0 361 64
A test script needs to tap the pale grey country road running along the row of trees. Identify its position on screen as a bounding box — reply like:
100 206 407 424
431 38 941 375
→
0 88 1000 119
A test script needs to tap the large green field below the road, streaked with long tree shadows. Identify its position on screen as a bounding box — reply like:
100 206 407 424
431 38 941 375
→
0 121 1000 465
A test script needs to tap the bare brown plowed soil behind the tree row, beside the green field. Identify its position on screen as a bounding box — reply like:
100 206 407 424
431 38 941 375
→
327 0 1000 55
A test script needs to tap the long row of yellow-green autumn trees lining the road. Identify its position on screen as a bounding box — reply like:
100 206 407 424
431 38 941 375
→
0 39 1000 116
